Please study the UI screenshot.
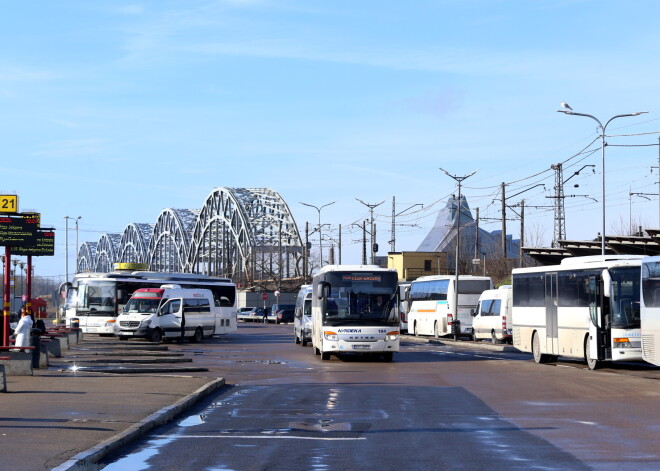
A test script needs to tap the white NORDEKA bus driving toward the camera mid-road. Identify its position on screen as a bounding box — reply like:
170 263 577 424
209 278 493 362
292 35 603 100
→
312 265 400 361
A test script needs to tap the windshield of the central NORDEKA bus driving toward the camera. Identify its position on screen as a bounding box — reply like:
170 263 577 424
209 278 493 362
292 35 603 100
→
323 272 398 325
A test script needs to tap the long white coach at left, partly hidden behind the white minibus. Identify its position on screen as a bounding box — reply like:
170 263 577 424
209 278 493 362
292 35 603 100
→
64 270 236 336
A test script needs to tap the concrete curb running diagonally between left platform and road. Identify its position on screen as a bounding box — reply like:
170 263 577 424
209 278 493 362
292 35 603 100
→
51 378 225 471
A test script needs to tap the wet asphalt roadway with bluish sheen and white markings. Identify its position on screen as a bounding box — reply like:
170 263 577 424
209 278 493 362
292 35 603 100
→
98 324 660 471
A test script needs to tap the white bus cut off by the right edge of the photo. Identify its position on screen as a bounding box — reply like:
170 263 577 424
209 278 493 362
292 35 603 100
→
641 256 660 366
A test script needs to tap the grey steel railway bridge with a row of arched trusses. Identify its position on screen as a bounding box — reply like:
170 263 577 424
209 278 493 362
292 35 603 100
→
76 187 303 288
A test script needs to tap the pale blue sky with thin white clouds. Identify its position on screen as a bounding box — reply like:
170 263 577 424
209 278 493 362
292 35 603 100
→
0 0 660 279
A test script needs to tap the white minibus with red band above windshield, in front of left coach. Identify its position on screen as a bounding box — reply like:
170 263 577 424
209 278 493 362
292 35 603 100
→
114 285 221 342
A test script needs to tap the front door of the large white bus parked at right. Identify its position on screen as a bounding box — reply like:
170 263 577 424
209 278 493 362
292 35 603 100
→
587 275 612 369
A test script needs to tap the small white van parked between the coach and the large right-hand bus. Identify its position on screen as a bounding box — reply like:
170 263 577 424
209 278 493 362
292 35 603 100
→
472 285 513 343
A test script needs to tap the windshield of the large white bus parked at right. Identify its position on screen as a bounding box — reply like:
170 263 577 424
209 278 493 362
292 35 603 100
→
610 267 640 328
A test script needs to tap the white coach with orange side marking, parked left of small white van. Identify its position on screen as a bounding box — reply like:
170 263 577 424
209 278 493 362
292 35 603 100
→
408 275 493 338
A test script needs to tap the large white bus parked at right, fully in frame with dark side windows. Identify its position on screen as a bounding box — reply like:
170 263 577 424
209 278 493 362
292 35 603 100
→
512 255 642 369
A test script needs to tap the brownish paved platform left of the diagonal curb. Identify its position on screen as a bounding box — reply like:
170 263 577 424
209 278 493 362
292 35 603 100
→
0 340 224 471
